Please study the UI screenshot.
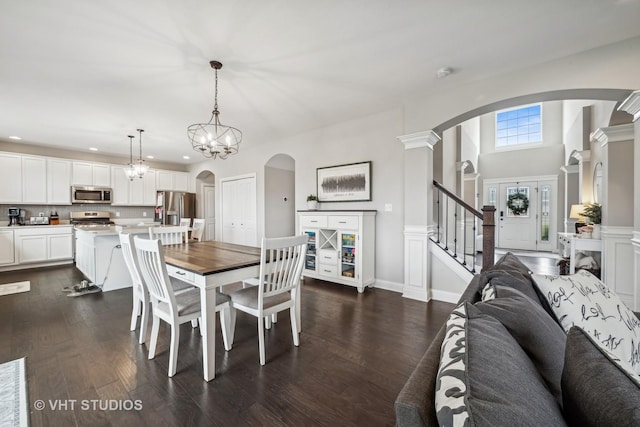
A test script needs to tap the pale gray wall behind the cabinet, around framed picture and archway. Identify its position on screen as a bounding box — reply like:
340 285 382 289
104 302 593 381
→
191 109 404 284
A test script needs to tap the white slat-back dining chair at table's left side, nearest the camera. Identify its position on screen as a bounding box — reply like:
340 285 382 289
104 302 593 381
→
133 236 233 377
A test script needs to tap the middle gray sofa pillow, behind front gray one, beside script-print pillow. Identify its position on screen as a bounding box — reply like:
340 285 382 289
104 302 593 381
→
475 286 566 403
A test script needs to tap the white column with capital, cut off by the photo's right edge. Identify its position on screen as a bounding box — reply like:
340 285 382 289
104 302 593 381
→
618 90 640 311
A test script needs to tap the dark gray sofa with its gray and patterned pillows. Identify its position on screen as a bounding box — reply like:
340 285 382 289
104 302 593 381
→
395 253 640 427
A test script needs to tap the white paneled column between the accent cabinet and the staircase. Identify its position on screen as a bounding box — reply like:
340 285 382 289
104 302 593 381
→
398 130 440 301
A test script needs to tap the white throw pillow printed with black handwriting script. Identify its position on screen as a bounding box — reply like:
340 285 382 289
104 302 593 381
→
533 270 640 374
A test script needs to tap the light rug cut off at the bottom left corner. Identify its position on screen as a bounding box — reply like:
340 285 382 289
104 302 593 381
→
0 357 29 427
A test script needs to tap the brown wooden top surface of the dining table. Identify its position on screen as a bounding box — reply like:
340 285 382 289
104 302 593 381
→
163 240 260 276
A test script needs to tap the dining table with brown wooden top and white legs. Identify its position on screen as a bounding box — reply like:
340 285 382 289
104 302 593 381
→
163 240 260 381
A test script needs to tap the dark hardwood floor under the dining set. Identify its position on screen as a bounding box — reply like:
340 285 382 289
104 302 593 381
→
0 266 453 426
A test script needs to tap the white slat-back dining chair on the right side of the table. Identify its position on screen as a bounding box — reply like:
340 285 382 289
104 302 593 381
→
229 234 309 365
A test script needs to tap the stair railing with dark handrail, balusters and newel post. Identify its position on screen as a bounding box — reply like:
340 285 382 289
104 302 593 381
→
431 180 496 274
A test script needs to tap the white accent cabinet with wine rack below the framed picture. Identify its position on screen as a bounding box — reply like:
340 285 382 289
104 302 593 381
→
298 210 376 293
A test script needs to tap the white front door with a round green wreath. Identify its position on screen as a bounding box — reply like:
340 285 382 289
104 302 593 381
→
496 181 538 250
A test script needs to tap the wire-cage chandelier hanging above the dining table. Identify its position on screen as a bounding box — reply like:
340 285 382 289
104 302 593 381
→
187 61 242 159
